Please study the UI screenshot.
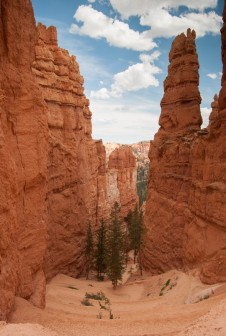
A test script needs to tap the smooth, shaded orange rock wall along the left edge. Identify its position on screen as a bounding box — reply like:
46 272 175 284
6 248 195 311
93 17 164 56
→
0 0 48 319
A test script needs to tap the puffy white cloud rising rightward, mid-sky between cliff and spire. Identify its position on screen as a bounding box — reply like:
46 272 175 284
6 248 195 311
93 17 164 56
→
91 50 161 99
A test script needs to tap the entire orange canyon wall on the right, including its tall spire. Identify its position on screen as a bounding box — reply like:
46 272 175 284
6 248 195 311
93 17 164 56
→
143 26 226 283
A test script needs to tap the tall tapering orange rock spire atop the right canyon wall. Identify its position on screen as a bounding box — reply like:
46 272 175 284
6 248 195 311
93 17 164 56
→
159 29 202 132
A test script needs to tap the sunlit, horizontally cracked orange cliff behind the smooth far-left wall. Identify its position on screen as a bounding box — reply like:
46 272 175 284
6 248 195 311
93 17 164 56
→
33 24 104 279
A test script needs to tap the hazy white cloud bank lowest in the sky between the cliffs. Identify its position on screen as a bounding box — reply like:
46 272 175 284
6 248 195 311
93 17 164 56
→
90 97 160 144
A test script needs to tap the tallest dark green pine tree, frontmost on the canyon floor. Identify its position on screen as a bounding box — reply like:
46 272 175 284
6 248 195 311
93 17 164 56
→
106 202 125 289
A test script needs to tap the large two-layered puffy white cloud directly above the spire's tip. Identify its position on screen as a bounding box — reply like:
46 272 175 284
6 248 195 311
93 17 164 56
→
110 0 222 39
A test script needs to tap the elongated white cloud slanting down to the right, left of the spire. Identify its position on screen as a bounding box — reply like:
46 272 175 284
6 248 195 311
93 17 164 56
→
70 5 156 51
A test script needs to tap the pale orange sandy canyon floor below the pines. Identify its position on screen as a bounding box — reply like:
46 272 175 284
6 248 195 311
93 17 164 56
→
0 266 226 336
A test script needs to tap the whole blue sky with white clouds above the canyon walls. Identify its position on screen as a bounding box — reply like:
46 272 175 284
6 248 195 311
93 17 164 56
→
32 0 224 143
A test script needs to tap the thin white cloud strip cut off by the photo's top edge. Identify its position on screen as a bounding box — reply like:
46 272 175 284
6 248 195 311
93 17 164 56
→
110 0 217 18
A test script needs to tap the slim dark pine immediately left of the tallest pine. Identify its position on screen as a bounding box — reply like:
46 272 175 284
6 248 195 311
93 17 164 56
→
95 219 107 280
